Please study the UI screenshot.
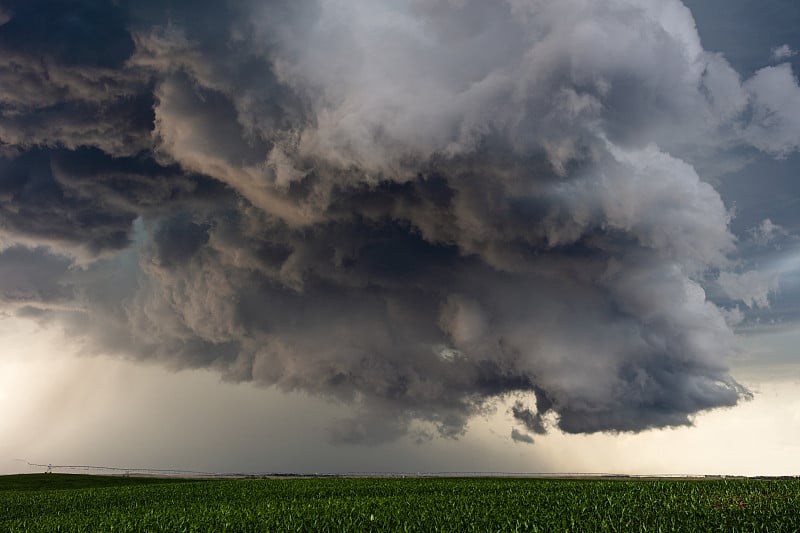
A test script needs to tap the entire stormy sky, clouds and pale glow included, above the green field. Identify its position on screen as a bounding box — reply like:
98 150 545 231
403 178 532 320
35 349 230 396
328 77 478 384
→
0 0 800 475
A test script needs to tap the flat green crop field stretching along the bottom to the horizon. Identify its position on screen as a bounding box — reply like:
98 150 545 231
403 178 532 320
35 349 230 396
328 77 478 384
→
0 474 800 532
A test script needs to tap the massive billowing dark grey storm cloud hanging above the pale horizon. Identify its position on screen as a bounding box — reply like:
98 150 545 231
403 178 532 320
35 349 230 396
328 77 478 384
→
0 0 800 443
